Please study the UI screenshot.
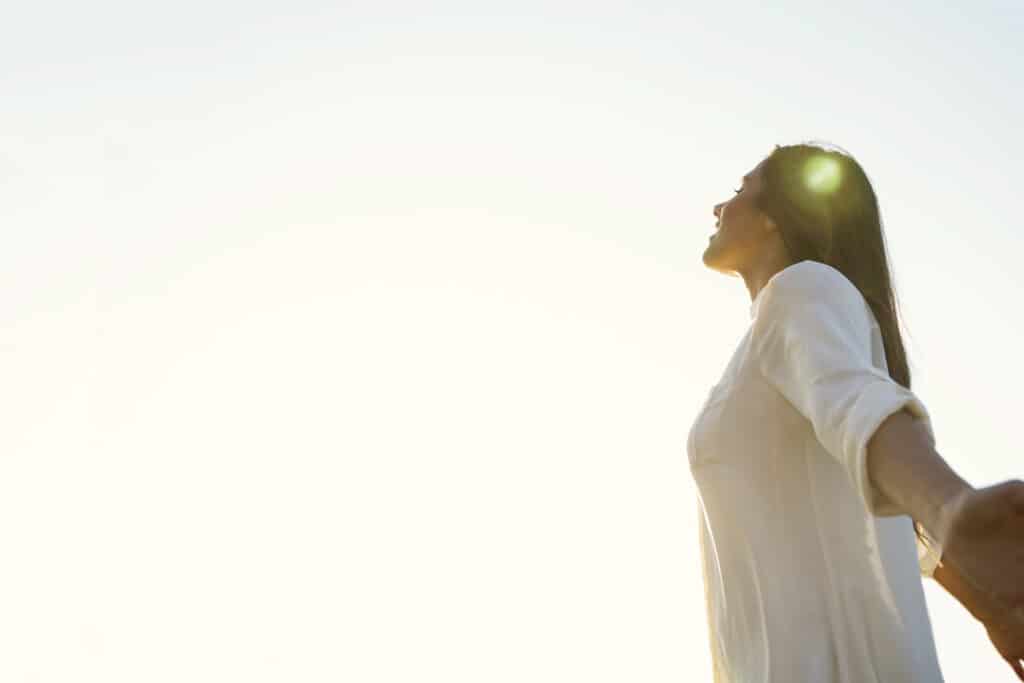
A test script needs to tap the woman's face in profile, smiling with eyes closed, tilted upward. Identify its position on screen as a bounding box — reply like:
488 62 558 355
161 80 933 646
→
702 161 781 273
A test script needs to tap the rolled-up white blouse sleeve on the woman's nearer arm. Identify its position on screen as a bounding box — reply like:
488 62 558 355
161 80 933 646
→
752 261 935 520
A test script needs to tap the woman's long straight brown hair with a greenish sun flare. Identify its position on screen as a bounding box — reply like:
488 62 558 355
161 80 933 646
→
755 142 930 545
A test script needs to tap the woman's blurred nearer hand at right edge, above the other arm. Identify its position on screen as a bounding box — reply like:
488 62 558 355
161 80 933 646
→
943 479 1024 610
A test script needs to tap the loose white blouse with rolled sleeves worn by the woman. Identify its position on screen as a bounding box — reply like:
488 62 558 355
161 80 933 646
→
687 260 942 683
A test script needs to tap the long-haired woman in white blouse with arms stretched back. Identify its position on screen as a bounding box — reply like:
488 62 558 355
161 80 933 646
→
687 144 1024 683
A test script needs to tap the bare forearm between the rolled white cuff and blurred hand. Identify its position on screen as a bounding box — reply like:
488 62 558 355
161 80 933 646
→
867 410 973 545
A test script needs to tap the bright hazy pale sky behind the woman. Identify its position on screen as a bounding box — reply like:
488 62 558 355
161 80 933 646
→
0 0 1024 683
